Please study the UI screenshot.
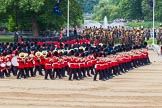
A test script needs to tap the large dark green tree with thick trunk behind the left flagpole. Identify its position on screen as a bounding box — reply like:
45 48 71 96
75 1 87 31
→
0 0 83 36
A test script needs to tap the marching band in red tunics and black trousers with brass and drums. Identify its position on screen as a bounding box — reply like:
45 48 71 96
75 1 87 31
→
0 43 150 81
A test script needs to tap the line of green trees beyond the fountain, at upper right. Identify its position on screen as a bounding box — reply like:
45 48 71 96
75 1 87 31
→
93 0 162 21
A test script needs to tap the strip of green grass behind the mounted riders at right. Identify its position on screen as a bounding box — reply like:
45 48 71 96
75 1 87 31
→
126 21 161 28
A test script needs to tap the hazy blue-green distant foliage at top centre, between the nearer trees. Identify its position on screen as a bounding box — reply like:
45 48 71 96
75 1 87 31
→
82 0 99 13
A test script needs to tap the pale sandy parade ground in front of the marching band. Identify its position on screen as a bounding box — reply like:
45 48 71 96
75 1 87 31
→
0 50 162 108
